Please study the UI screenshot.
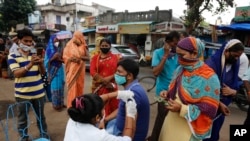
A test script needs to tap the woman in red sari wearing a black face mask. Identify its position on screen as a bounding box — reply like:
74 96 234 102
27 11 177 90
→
90 38 119 132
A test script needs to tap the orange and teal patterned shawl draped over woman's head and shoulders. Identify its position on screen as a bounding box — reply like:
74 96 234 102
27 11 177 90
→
167 37 220 140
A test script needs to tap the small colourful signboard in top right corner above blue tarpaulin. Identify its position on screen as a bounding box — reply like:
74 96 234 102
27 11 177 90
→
234 6 250 22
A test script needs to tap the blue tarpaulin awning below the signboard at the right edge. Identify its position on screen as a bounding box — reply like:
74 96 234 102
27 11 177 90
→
217 23 250 31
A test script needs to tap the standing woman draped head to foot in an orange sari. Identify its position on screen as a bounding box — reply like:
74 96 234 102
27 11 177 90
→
63 31 89 108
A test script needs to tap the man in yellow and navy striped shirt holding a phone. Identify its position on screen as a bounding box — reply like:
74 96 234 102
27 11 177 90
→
8 29 47 141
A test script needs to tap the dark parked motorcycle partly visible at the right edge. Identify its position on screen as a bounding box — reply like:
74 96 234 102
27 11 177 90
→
233 85 249 112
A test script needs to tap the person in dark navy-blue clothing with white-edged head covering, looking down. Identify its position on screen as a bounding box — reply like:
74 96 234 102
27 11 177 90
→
205 39 244 141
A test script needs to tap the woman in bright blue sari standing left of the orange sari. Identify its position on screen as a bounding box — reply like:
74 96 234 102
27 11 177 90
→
44 35 66 111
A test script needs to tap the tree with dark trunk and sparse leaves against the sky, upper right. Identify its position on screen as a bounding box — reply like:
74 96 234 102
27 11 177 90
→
181 0 235 33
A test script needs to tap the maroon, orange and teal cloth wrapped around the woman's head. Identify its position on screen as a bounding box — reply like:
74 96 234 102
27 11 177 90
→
177 37 205 58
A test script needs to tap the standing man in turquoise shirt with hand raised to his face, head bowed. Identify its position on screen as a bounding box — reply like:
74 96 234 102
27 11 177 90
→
149 31 180 141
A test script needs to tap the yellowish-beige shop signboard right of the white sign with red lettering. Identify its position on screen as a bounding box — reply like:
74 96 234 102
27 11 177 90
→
119 24 150 34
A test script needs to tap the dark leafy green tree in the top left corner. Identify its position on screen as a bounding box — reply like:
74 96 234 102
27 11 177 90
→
0 0 36 32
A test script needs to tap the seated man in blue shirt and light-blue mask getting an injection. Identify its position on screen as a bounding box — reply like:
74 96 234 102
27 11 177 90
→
104 59 150 141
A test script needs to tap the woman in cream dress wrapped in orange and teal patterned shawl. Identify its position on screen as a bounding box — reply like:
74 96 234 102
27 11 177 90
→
159 37 220 141
